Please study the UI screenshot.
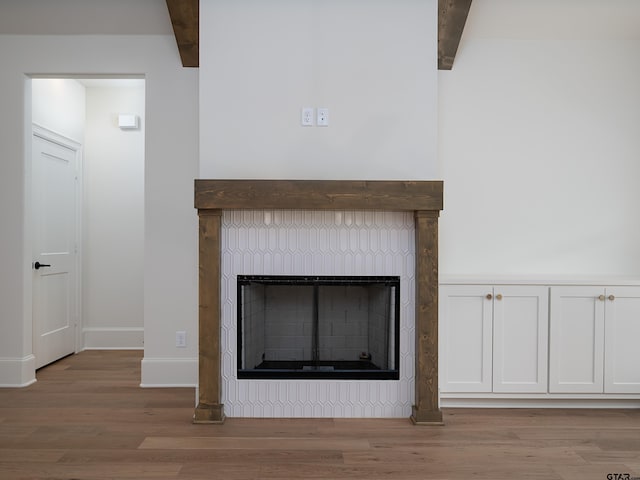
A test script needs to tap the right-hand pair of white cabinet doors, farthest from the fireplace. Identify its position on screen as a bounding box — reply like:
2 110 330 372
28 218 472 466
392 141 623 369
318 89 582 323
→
549 286 640 394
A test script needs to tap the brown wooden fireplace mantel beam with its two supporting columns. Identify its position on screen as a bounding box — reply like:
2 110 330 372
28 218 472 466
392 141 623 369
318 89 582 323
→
193 180 443 425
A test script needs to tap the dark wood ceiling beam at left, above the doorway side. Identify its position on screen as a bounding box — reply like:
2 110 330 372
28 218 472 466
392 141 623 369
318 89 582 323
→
167 0 200 67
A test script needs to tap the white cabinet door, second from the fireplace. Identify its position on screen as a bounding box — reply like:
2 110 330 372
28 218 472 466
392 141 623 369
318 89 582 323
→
493 285 549 393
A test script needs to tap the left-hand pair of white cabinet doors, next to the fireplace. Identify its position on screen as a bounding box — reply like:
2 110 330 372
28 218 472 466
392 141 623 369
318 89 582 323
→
440 285 549 393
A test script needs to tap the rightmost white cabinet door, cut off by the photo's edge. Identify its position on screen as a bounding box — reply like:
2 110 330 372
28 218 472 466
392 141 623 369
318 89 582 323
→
604 287 640 393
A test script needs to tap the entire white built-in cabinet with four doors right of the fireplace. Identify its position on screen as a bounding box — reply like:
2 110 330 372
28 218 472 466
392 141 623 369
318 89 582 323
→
439 279 640 407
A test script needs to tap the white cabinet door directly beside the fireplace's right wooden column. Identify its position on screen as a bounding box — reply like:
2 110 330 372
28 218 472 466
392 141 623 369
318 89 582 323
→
440 285 493 392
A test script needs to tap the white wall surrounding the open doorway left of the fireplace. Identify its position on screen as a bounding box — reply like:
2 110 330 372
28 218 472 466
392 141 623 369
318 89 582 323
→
0 33 198 385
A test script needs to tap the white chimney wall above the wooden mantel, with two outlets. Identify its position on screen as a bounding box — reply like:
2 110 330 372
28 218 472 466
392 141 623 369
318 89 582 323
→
200 0 438 180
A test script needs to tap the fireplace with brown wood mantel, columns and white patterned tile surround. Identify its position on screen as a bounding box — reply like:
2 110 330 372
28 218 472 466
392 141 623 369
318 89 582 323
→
194 180 442 424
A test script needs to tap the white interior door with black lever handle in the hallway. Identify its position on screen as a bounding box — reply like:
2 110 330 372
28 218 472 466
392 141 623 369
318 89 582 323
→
32 126 80 368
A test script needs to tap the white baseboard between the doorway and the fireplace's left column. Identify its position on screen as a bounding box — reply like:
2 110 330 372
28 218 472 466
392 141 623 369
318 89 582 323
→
140 357 198 388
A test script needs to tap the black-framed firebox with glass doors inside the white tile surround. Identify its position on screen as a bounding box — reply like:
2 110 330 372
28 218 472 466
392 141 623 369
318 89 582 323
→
237 275 400 380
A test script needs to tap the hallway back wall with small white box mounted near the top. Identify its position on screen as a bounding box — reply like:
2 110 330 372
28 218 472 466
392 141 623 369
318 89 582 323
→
82 84 145 349
